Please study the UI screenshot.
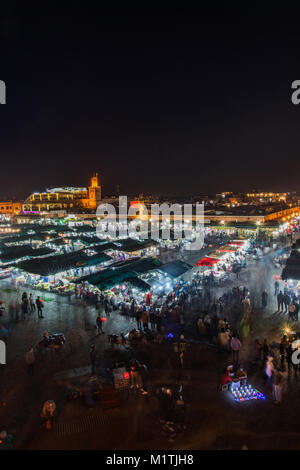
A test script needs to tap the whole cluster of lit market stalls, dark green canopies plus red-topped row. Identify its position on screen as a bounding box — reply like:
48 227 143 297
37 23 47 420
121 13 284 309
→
0 218 255 298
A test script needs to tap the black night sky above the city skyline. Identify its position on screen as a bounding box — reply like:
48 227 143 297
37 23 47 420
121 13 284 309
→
0 2 300 198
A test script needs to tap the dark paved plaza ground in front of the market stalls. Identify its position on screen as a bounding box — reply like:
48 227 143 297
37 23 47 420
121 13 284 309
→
0 244 300 449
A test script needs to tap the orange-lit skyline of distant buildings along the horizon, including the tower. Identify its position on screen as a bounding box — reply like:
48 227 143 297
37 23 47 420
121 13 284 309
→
0 177 300 224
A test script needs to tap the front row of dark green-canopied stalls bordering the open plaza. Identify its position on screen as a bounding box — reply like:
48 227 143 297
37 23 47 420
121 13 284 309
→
8 252 192 302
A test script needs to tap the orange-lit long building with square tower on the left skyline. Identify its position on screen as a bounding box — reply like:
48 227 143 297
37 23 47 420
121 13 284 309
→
22 173 101 212
